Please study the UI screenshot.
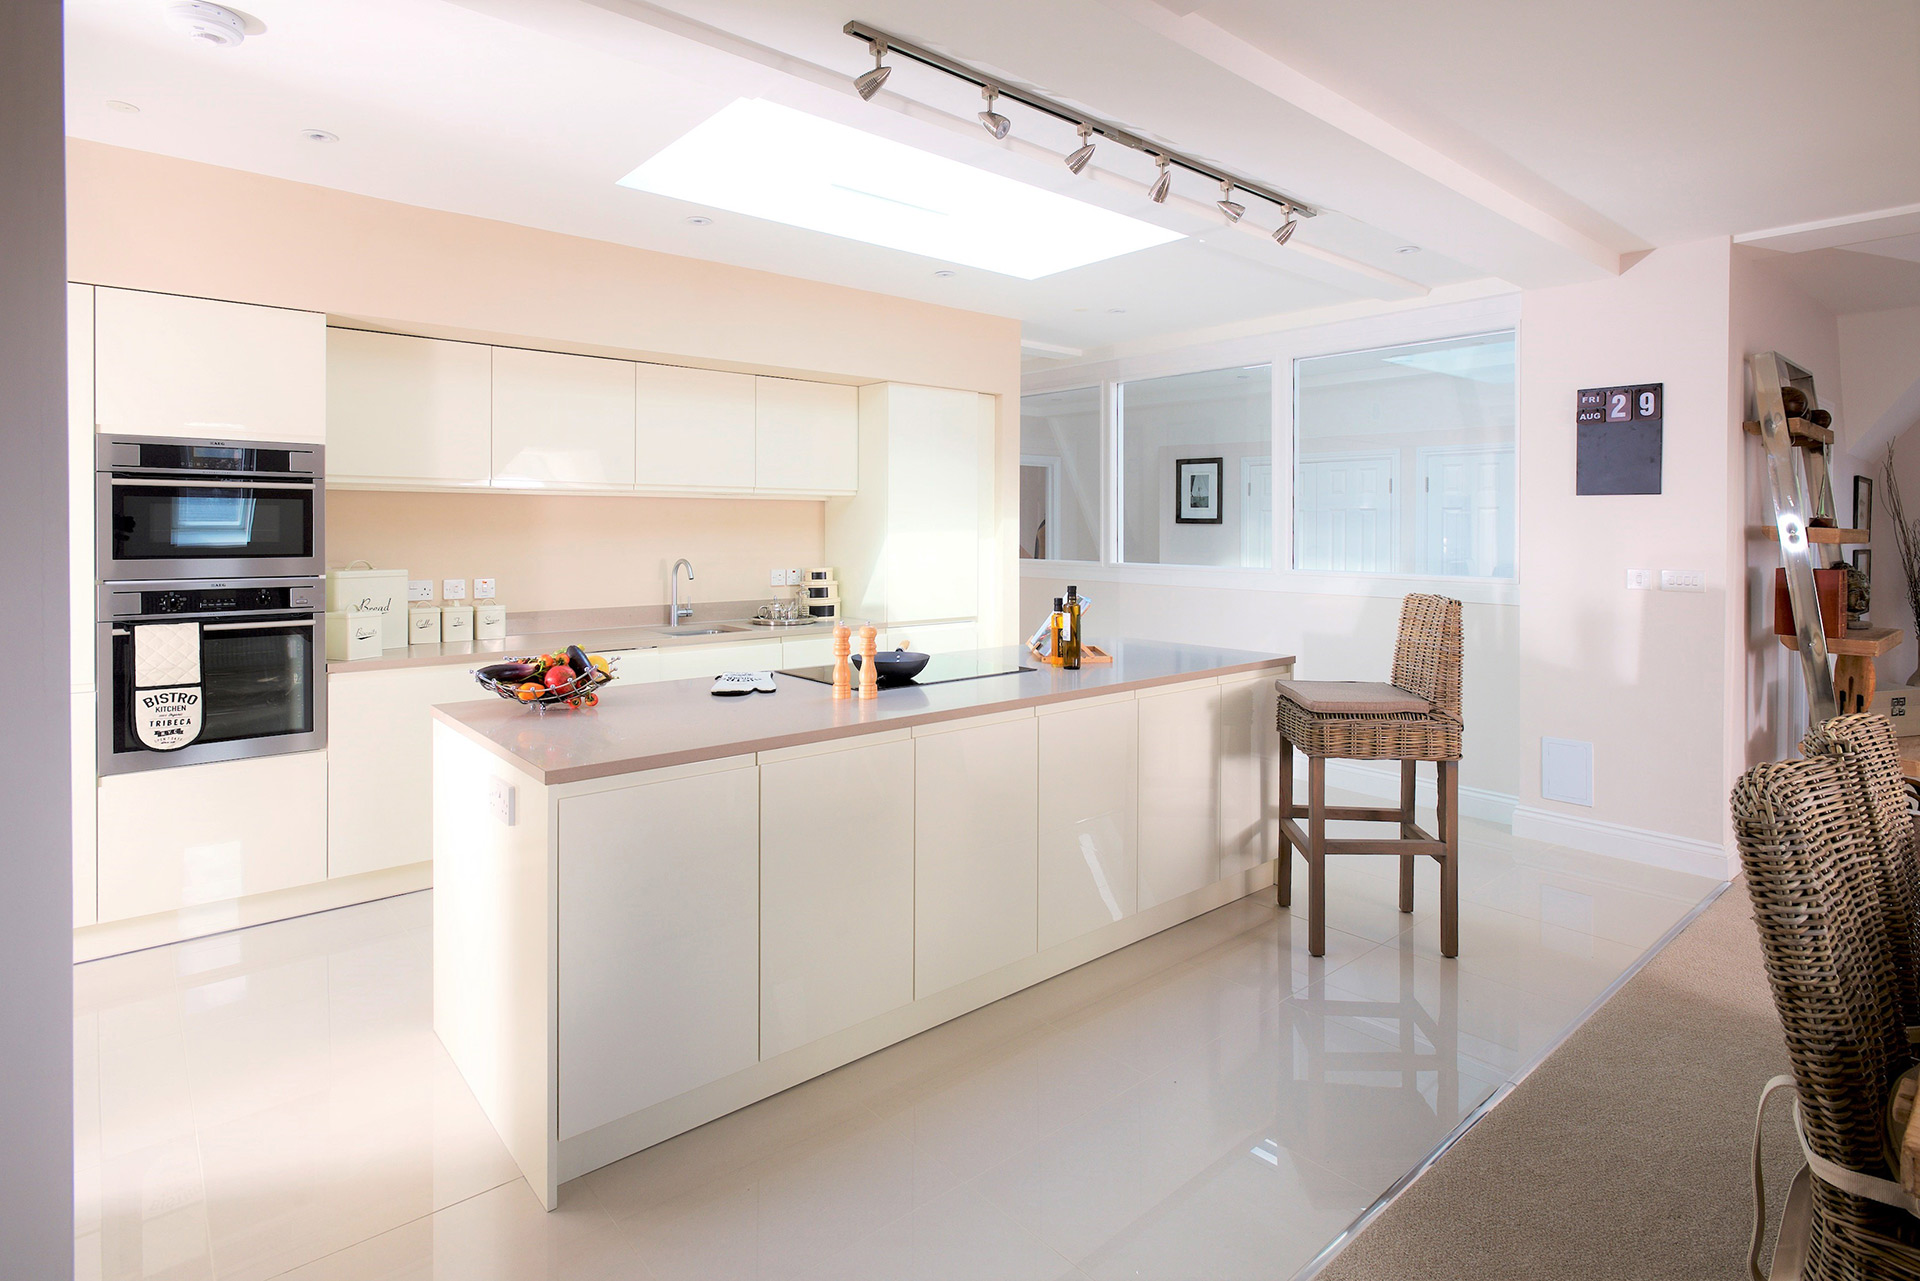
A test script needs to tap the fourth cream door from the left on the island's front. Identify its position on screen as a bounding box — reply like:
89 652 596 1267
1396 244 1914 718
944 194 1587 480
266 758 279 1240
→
1039 695 1140 951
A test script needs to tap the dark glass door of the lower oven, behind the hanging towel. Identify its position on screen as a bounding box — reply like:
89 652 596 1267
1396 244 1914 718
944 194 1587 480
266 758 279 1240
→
102 615 324 770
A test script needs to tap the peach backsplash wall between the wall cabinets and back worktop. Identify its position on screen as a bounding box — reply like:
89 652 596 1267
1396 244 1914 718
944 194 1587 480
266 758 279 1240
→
326 490 826 611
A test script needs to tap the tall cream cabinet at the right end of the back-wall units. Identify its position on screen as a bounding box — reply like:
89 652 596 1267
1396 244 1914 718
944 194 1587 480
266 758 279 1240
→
826 382 1010 645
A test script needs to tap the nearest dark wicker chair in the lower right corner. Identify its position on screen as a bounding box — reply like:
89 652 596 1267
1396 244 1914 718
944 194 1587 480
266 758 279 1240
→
1732 756 1920 1281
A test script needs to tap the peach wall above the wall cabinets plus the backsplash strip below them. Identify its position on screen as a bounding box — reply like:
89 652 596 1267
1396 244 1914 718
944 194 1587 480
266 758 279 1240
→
67 140 1020 636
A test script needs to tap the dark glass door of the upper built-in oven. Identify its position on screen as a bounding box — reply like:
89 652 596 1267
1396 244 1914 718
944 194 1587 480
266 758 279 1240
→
100 476 319 582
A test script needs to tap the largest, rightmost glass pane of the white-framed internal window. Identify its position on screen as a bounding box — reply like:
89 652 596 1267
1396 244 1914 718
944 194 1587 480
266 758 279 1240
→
1294 330 1515 578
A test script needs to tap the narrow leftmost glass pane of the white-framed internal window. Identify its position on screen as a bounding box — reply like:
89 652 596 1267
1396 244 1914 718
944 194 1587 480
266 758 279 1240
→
1020 386 1102 561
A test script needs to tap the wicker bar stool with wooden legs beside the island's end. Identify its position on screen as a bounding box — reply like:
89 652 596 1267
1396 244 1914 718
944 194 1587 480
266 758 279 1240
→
1275 595 1461 956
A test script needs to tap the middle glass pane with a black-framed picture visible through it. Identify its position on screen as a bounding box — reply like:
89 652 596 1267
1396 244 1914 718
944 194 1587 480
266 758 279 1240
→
1119 365 1273 568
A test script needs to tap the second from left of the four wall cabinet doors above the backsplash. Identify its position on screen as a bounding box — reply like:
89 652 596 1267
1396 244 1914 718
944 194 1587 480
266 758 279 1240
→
493 348 634 490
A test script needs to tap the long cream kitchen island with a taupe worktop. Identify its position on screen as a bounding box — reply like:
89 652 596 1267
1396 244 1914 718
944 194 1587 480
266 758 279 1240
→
434 641 1292 1208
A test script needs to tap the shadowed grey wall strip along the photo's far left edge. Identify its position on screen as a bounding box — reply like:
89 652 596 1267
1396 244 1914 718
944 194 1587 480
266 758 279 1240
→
0 0 73 1281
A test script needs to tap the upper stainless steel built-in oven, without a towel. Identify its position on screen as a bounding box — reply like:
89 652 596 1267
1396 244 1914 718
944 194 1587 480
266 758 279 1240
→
94 436 326 582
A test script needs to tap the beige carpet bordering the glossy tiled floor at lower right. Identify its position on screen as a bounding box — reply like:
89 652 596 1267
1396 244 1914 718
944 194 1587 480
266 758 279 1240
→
1319 882 1799 1281
